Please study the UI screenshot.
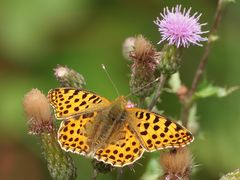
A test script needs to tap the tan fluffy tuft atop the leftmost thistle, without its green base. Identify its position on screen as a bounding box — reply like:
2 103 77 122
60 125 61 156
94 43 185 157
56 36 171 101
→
23 89 53 134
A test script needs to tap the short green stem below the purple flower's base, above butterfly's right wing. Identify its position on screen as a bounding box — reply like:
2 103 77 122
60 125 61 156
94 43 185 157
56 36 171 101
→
148 74 167 111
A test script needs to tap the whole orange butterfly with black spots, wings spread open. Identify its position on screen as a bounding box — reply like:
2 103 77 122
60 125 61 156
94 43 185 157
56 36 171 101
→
48 88 194 167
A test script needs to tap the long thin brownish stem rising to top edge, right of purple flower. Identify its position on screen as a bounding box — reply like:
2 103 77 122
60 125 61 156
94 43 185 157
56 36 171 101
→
181 0 223 126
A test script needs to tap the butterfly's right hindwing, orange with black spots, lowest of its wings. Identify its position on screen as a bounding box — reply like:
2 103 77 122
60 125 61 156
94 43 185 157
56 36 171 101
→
94 126 144 167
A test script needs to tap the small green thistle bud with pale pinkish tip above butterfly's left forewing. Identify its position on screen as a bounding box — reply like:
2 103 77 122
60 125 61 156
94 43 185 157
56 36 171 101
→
54 65 86 89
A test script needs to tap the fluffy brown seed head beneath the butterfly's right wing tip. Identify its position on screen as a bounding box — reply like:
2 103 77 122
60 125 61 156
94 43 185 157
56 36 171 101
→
160 148 192 180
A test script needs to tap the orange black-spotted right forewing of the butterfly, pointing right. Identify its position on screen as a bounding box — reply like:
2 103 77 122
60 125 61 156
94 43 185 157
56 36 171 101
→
127 108 194 151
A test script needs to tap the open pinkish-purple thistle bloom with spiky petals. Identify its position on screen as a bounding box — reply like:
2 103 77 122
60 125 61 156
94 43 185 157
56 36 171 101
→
154 5 208 47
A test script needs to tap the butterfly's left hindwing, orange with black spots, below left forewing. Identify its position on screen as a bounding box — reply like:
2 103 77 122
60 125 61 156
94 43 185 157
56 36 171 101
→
58 112 97 155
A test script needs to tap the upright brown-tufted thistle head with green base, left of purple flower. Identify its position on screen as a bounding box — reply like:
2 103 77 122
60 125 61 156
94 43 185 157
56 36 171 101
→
130 35 159 97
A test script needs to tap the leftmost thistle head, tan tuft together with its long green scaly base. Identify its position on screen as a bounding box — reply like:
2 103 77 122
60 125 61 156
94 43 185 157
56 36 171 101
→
23 89 76 179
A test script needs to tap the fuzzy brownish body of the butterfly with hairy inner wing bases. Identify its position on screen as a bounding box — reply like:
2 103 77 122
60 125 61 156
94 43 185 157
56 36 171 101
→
86 97 127 153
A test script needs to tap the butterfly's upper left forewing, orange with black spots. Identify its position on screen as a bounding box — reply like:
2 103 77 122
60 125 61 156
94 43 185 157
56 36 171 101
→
48 88 110 119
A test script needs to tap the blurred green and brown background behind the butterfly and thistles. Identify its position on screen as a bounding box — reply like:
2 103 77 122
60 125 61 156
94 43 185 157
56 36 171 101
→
0 0 240 180
